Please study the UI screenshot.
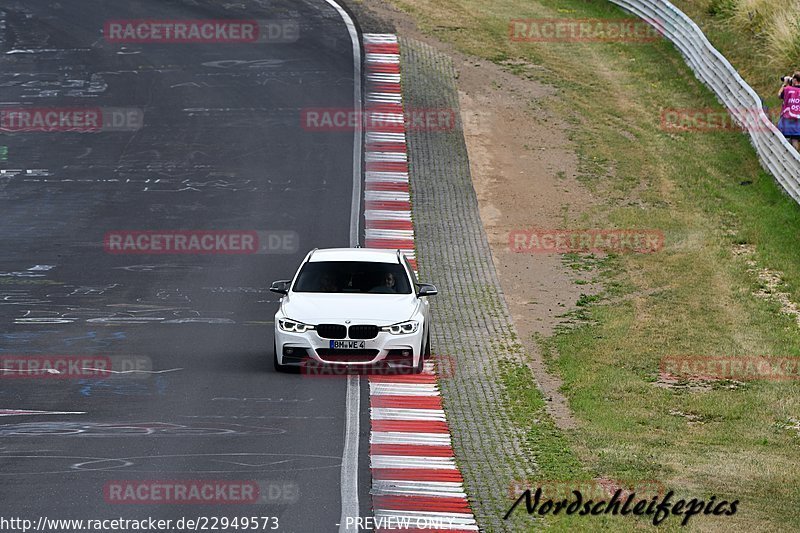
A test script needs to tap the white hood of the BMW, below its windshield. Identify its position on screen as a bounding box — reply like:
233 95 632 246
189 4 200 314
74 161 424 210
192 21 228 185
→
281 293 417 326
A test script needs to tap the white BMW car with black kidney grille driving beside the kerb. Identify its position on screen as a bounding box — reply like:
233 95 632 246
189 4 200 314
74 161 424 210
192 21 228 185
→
270 248 437 372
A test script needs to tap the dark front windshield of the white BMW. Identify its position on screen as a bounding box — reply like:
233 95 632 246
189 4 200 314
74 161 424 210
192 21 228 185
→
293 261 411 294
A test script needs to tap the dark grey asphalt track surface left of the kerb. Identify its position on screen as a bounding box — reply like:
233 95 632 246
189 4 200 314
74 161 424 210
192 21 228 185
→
0 0 368 532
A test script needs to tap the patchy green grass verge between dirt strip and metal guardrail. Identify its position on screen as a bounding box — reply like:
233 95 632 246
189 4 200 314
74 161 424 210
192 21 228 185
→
394 0 800 531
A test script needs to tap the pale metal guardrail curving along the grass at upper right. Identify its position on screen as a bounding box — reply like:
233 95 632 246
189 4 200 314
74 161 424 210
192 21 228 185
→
610 0 800 203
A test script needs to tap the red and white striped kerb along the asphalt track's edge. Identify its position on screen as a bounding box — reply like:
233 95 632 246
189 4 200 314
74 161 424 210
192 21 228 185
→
363 34 478 533
